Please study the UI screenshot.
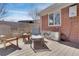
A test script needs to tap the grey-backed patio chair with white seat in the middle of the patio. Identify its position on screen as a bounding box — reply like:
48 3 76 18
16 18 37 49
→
31 27 44 50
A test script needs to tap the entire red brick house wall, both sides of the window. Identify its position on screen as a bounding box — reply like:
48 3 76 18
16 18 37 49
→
42 4 79 43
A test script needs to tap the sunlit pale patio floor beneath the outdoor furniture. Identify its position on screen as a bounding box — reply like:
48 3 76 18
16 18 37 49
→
0 39 79 56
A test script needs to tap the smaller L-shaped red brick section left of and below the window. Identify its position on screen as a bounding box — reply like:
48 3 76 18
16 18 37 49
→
42 15 59 31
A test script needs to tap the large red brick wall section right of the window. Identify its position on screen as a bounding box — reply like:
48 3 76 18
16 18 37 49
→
61 4 79 43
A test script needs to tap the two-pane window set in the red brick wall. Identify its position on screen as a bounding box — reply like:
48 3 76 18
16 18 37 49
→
48 13 60 26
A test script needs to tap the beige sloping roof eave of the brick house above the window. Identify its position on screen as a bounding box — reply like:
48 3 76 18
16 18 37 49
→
40 3 74 16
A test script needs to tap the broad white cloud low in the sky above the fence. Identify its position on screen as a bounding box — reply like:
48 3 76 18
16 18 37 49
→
3 10 33 21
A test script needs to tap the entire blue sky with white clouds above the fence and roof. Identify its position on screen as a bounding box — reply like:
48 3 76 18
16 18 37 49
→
2 3 51 22
